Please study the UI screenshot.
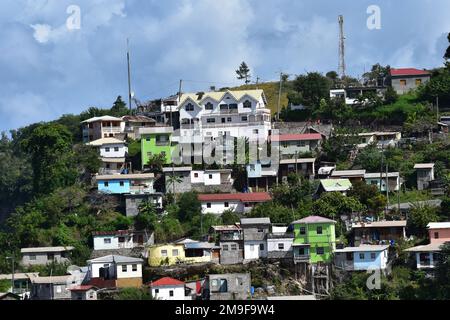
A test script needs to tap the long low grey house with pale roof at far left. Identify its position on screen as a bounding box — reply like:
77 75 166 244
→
20 247 74 266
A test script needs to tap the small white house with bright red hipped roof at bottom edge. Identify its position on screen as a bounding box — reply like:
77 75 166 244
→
150 277 191 300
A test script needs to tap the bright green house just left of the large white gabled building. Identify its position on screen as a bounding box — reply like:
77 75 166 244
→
139 127 175 168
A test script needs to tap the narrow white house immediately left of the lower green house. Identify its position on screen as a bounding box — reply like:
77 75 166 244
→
267 225 294 260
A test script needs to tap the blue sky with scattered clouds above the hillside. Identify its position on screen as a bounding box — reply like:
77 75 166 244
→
0 0 450 131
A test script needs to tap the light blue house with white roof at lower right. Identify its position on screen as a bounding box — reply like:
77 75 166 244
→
334 245 389 271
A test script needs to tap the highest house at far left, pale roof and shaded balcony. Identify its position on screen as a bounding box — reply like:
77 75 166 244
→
81 116 125 142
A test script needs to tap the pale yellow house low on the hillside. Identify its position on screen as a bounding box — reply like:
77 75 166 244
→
148 244 185 267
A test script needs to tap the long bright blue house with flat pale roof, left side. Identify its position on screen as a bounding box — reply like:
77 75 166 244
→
96 173 155 194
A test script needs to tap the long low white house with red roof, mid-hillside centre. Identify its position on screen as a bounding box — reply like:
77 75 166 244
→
198 192 271 215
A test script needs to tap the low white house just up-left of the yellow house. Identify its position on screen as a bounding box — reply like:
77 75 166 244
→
92 230 151 250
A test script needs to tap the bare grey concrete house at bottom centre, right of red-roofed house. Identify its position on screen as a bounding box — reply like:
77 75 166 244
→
202 273 251 300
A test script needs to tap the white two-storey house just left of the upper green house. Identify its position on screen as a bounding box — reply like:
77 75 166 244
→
87 138 128 174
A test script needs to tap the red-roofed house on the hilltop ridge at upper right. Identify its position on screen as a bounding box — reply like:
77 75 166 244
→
390 68 431 94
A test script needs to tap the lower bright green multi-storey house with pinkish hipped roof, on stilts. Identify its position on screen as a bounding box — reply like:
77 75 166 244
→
292 216 336 263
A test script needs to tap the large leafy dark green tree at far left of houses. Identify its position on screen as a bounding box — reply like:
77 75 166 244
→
23 124 76 194
